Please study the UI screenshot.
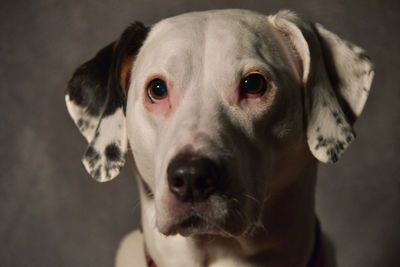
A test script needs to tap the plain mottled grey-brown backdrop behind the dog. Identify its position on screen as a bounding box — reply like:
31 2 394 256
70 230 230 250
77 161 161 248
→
0 0 400 267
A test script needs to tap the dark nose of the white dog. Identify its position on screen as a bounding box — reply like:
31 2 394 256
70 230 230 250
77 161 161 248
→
167 155 221 203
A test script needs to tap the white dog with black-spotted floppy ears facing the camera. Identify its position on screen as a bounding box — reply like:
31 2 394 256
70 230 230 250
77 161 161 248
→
65 10 374 267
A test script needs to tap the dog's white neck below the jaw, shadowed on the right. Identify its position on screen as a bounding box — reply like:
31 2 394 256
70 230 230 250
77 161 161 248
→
141 148 317 267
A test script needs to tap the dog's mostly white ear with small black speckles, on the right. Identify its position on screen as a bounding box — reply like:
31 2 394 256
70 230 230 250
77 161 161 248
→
269 11 374 162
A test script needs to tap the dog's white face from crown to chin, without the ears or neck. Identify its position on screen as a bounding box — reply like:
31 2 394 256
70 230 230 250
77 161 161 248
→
126 13 304 237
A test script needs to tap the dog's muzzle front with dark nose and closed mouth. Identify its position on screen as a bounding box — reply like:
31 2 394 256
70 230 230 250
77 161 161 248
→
162 153 242 236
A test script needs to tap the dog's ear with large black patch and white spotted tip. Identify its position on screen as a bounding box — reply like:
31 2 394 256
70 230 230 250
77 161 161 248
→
65 22 148 182
